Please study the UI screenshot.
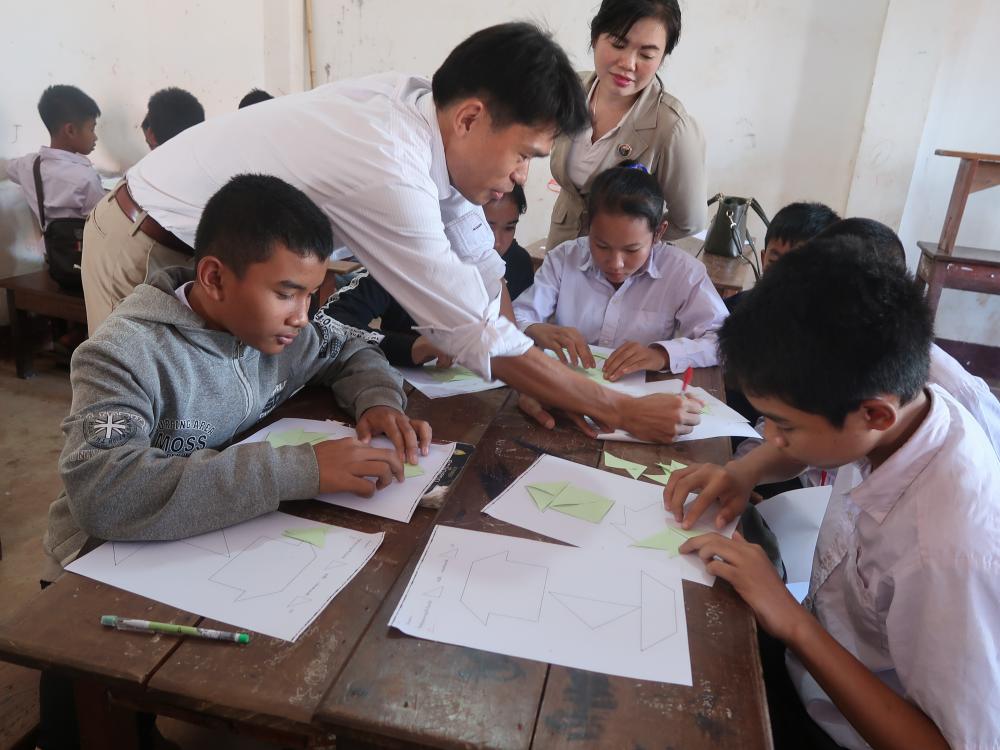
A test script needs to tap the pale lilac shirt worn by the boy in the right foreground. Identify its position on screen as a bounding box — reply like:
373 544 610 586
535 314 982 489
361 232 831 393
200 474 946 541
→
786 386 1000 750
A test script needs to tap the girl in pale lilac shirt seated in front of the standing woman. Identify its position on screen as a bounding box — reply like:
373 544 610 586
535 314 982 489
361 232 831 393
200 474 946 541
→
514 162 726 388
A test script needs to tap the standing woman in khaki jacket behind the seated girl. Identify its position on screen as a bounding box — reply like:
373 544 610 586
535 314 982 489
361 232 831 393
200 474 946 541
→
547 0 708 253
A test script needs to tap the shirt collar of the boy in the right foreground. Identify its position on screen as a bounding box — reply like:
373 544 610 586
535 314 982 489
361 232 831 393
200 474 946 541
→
847 387 951 524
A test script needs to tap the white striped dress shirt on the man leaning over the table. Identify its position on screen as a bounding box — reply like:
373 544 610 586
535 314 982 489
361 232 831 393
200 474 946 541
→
127 73 531 379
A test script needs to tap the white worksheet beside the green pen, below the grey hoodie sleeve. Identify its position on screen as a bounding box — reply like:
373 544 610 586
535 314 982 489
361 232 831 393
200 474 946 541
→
66 512 385 641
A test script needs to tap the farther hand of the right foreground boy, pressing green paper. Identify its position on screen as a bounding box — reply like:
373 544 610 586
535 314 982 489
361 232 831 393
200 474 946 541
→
663 464 753 529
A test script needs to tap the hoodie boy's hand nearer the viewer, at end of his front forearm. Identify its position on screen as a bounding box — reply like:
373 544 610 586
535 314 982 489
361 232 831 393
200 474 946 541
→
313 438 403 497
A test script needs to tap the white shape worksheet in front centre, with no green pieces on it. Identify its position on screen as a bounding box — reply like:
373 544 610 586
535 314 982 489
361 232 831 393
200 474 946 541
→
389 526 691 685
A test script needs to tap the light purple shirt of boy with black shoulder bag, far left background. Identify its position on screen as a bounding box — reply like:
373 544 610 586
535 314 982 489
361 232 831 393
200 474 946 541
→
7 146 104 229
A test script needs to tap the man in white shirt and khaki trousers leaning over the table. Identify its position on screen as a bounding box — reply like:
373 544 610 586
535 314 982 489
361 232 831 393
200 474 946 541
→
83 24 698 441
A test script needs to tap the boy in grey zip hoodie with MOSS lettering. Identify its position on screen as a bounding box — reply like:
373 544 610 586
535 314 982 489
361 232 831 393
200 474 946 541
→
44 175 431 580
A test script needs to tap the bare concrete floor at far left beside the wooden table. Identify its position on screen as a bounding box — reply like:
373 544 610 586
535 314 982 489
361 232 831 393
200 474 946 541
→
0 356 278 750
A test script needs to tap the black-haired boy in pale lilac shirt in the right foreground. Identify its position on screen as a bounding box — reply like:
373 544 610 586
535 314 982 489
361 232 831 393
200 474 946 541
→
664 237 1000 748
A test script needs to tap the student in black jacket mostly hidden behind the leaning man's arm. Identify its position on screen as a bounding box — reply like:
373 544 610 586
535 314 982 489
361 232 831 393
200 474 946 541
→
317 185 534 367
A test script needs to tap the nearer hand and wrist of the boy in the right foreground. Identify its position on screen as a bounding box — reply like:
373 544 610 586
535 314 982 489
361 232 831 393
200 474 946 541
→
680 532 810 641
